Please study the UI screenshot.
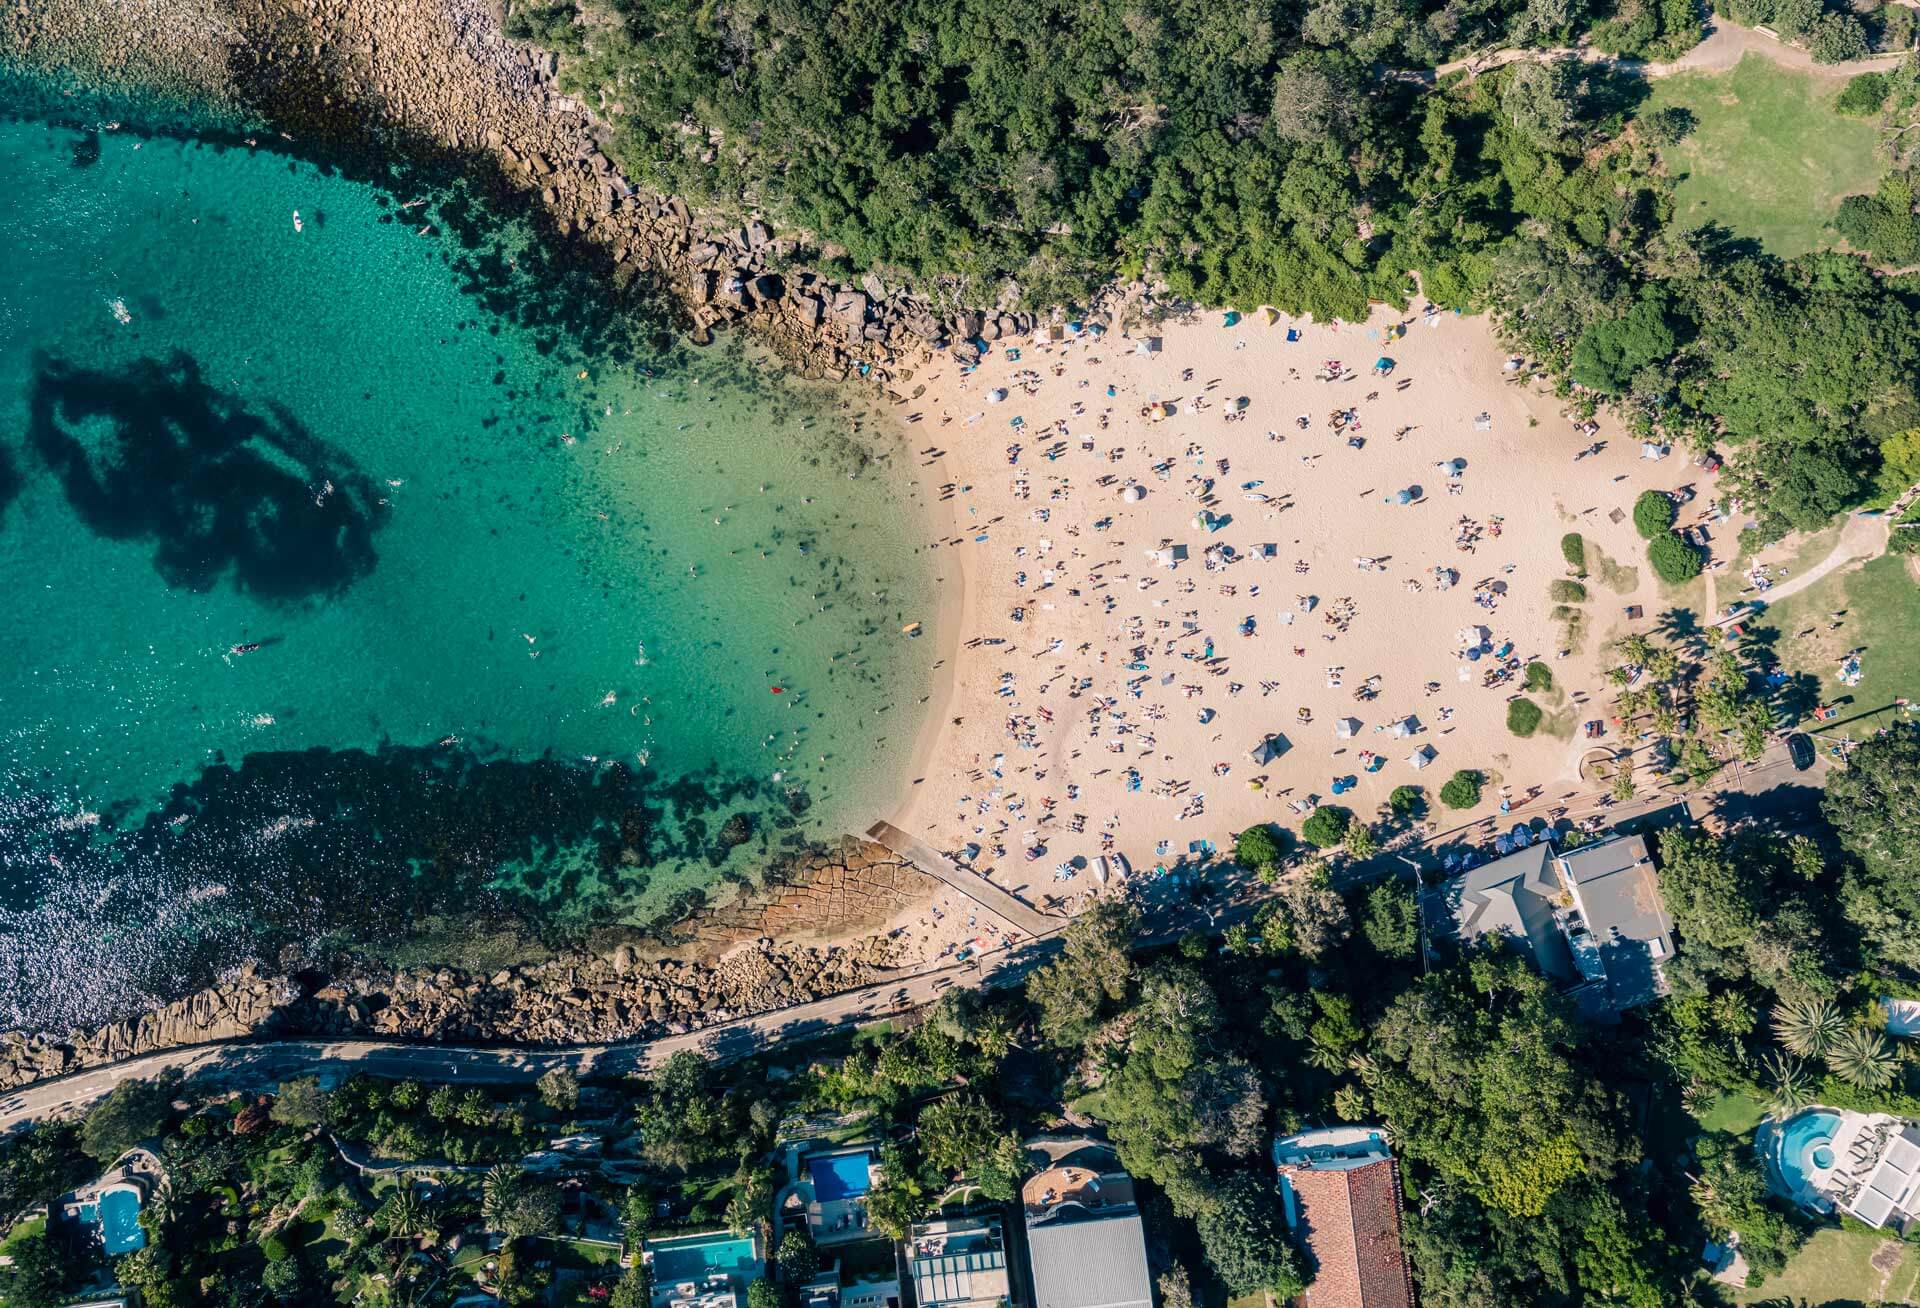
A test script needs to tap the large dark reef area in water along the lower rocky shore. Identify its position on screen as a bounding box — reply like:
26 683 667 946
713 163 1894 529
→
0 733 817 1029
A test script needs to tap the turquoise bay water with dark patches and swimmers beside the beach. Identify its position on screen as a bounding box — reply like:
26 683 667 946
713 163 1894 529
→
0 76 937 1029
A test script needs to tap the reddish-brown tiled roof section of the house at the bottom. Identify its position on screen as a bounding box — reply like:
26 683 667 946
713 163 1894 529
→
1281 1160 1413 1308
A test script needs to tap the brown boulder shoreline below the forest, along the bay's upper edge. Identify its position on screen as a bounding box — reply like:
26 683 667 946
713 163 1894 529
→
0 0 1035 382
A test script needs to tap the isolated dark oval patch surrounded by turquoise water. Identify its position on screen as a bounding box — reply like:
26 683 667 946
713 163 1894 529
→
27 351 378 601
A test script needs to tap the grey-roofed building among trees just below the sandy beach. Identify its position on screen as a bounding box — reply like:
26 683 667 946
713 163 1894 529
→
1423 836 1674 1018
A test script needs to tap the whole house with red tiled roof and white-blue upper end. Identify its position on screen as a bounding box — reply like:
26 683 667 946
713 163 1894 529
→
1273 1126 1413 1308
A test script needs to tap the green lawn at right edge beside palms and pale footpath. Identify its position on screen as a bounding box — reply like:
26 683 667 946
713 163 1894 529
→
1753 555 1920 739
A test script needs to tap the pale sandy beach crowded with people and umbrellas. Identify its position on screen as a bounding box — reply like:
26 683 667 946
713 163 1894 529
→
889 293 1713 929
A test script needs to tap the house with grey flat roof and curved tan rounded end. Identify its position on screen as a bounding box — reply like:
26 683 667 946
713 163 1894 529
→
1020 1147 1154 1308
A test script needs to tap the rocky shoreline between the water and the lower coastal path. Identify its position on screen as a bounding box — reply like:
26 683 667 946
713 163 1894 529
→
0 841 933 1091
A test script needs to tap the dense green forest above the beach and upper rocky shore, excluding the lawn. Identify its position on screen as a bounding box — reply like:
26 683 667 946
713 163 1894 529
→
509 0 1920 536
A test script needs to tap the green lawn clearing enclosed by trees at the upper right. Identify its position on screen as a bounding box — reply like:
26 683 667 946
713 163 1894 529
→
1640 54 1882 257
